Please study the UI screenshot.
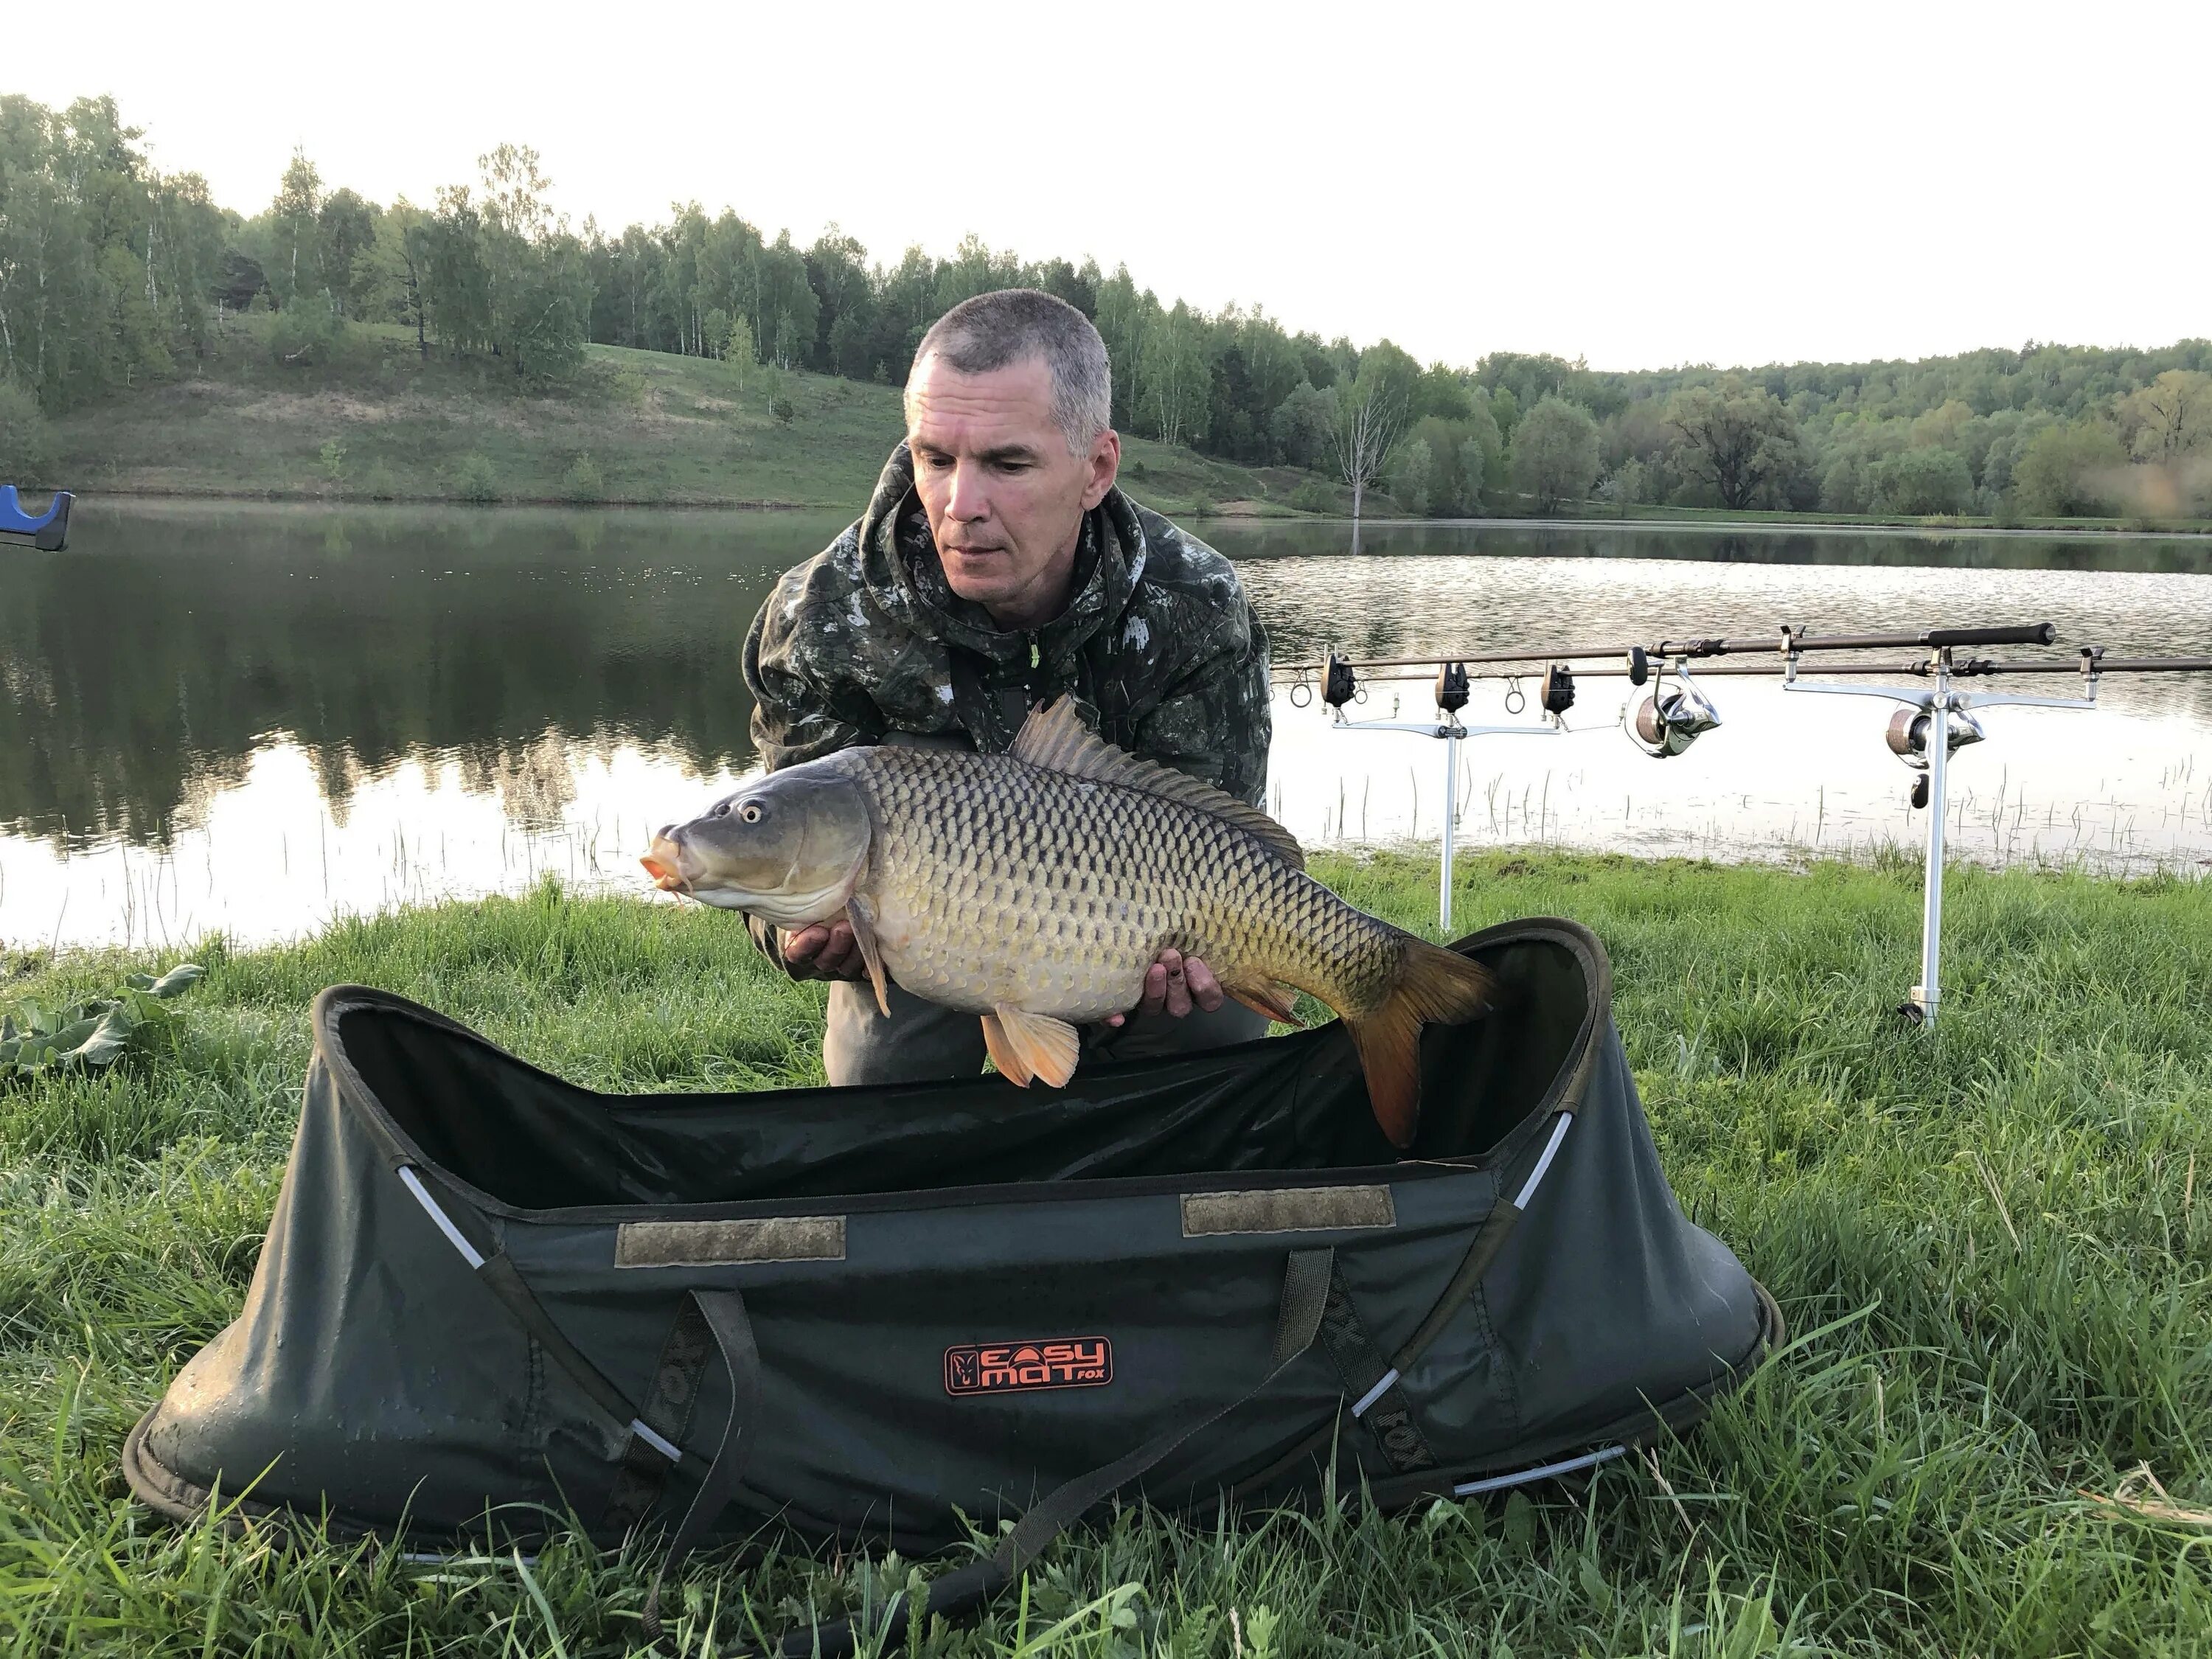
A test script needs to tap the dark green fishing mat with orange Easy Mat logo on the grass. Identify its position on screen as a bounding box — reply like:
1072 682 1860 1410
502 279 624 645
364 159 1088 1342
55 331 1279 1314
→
124 920 1781 1650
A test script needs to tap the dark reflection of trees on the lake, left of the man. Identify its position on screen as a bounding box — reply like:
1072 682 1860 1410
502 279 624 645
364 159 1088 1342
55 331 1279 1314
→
0 509 838 847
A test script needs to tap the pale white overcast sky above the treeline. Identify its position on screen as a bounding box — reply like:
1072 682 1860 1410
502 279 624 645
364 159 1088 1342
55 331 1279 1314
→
21 0 2212 367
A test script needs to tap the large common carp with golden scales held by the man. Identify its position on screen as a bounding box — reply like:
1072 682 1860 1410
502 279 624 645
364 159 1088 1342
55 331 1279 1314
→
644 699 1491 1146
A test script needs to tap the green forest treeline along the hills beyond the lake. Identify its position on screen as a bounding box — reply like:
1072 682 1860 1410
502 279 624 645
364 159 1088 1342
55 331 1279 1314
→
0 97 2212 518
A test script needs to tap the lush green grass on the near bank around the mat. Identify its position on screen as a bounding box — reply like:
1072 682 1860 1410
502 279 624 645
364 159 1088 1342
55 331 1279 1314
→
0 854 2212 1659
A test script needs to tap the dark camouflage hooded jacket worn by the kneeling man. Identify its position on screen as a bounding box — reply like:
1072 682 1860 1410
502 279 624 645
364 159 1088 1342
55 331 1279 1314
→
745 445 1272 805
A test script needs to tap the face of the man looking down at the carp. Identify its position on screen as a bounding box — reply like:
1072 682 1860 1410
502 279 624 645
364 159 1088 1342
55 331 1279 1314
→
907 352 1121 628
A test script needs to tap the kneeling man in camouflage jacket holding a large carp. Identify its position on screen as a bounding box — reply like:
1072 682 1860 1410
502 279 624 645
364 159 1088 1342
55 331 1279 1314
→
745 288 1270 1084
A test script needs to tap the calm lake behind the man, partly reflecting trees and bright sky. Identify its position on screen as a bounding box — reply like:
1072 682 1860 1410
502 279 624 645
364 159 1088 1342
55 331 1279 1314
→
0 502 2212 947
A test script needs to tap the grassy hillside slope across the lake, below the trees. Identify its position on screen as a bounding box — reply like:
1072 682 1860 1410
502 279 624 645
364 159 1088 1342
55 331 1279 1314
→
55 316 1305 513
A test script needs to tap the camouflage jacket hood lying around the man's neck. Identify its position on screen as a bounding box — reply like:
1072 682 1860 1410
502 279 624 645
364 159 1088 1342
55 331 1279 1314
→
856 445 1148 668
